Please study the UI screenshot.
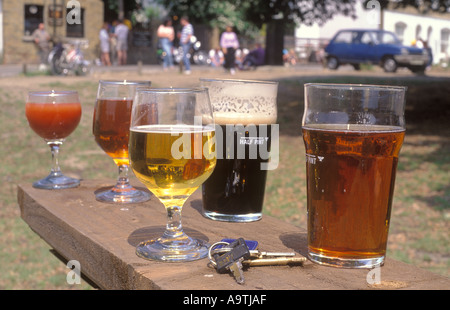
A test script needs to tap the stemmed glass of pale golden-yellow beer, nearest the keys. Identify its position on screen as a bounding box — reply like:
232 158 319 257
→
129 88 216 262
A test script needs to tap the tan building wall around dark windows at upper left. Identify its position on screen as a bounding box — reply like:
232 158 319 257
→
2 0 103 64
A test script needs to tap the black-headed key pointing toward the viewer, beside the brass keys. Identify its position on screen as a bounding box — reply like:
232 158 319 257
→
213 238 250 284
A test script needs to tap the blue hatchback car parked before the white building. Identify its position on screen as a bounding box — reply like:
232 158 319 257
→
325 29 431 74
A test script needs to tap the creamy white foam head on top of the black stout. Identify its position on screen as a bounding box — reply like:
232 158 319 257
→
202 80 278 125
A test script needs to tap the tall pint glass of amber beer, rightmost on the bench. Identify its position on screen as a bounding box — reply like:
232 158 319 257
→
302 84 406 268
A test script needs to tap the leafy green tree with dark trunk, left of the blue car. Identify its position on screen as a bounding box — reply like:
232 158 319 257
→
157 0 450 65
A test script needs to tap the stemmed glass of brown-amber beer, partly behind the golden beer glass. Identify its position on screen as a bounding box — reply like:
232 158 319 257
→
92 80 151 203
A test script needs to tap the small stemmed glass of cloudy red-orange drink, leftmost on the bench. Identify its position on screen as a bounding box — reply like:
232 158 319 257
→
25 90 81 189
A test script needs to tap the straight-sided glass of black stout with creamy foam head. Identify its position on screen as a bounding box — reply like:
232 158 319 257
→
200 78 278 222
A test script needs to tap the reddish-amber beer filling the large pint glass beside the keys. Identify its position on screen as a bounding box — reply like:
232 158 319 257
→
303 125 405 259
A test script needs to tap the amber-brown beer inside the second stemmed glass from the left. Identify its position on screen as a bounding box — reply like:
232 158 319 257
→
93 99 133 166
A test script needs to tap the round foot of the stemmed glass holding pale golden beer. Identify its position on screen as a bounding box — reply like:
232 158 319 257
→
136 237 209 262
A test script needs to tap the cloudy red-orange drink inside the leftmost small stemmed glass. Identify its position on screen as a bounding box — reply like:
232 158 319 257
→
25 102 81 140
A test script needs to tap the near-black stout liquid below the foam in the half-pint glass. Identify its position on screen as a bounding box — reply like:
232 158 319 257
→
203 125 271 215
